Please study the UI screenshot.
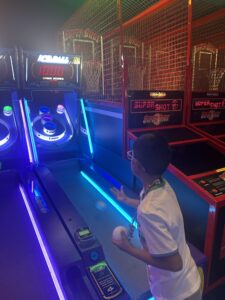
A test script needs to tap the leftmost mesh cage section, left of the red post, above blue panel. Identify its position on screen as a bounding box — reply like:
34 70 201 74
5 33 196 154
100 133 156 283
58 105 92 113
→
59 0 122 101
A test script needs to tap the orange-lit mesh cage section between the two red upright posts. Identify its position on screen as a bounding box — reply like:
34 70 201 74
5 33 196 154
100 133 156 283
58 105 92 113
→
121 1 188 90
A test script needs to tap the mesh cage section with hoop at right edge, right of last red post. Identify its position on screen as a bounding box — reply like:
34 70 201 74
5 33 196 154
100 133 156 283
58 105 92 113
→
192 0 225 92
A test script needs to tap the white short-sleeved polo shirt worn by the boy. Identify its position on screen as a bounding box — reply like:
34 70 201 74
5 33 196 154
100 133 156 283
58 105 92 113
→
137 182 200 300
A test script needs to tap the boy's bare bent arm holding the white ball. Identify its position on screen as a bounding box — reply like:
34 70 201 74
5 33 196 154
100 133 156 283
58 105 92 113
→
113 235 183 272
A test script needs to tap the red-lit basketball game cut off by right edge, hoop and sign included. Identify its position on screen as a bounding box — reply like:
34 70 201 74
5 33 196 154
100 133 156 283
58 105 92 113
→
187 19 225 148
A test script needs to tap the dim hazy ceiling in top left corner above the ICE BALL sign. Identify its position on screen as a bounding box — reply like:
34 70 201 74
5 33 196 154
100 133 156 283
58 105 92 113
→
0 0 85 51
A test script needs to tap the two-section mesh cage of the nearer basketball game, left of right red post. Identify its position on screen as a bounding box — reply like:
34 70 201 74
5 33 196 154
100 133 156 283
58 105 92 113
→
57 0 188 101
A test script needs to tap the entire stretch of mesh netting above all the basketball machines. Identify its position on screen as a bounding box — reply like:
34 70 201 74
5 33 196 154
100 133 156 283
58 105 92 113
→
60 0 225 101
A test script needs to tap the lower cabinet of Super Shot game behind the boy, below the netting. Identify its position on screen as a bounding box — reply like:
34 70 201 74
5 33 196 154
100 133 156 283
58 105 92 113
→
128 91 225 287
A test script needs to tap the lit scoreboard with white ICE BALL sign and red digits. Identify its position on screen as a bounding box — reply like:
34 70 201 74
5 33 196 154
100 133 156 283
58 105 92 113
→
23 52 81 89
